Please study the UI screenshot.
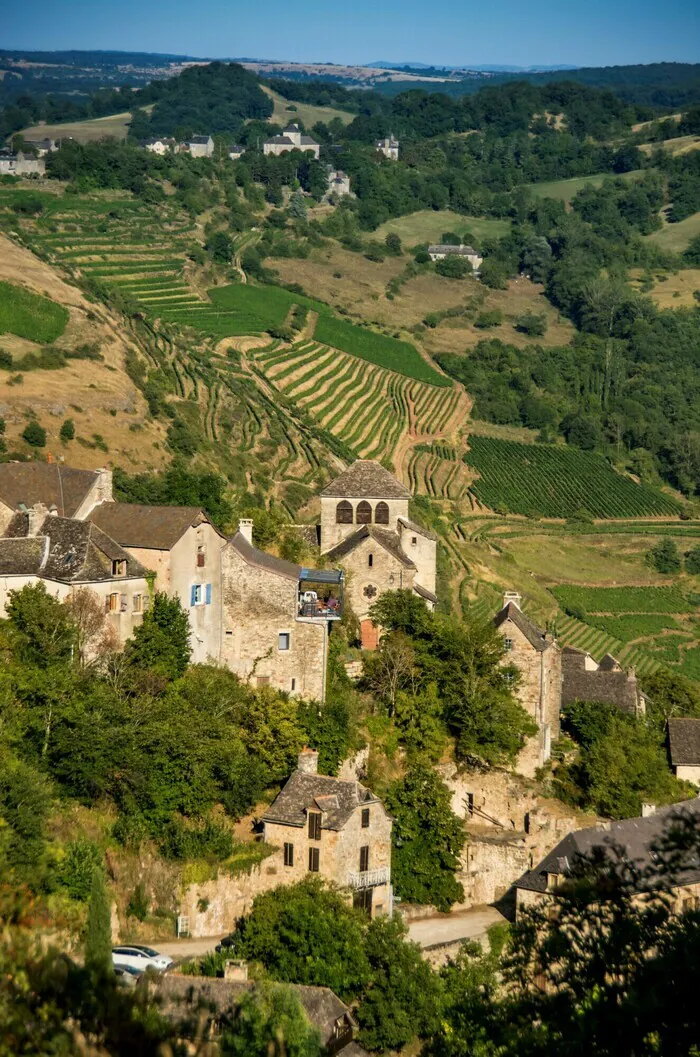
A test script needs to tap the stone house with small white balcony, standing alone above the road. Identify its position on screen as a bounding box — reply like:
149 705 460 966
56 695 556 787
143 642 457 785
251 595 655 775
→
262 749 392 917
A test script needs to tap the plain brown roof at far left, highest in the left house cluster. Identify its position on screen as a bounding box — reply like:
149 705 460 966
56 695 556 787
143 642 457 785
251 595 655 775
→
0 462 99 518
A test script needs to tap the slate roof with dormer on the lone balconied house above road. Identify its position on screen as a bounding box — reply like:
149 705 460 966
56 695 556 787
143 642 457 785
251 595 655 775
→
262 771 380 830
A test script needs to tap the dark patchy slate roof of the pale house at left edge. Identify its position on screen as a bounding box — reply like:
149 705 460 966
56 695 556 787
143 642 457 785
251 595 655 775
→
0 514 147 583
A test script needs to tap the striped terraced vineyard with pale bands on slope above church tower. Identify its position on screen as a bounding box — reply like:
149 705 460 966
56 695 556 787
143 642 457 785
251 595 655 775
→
255 340 464 471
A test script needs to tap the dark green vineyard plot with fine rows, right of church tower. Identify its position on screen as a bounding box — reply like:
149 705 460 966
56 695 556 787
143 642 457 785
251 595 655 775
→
464 435 678 518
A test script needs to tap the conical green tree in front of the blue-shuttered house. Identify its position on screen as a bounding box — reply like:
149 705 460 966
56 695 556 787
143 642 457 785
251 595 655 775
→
124 591 191 681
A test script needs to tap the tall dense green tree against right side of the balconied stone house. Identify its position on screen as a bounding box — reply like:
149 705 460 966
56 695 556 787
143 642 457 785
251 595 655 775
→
386 766 465 911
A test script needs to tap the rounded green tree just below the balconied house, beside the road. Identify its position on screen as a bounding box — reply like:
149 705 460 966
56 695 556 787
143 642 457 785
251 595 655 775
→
232 877 370 998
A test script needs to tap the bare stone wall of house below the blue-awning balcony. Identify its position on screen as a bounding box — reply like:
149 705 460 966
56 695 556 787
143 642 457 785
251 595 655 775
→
221 544 328 701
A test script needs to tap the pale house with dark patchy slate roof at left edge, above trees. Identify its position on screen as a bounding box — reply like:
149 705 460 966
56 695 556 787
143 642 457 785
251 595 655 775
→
0 503 150 644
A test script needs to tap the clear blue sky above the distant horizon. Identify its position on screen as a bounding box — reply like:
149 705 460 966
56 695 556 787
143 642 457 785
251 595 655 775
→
0 0 700 67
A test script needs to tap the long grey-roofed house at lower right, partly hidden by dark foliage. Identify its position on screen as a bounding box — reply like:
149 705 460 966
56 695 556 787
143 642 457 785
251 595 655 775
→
515 798 700 914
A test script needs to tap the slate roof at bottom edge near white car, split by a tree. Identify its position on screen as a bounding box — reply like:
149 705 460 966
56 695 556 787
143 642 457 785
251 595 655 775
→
152 973 367 1057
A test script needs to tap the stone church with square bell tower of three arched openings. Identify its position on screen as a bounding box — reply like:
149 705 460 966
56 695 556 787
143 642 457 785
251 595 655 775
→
320 459 438 649
